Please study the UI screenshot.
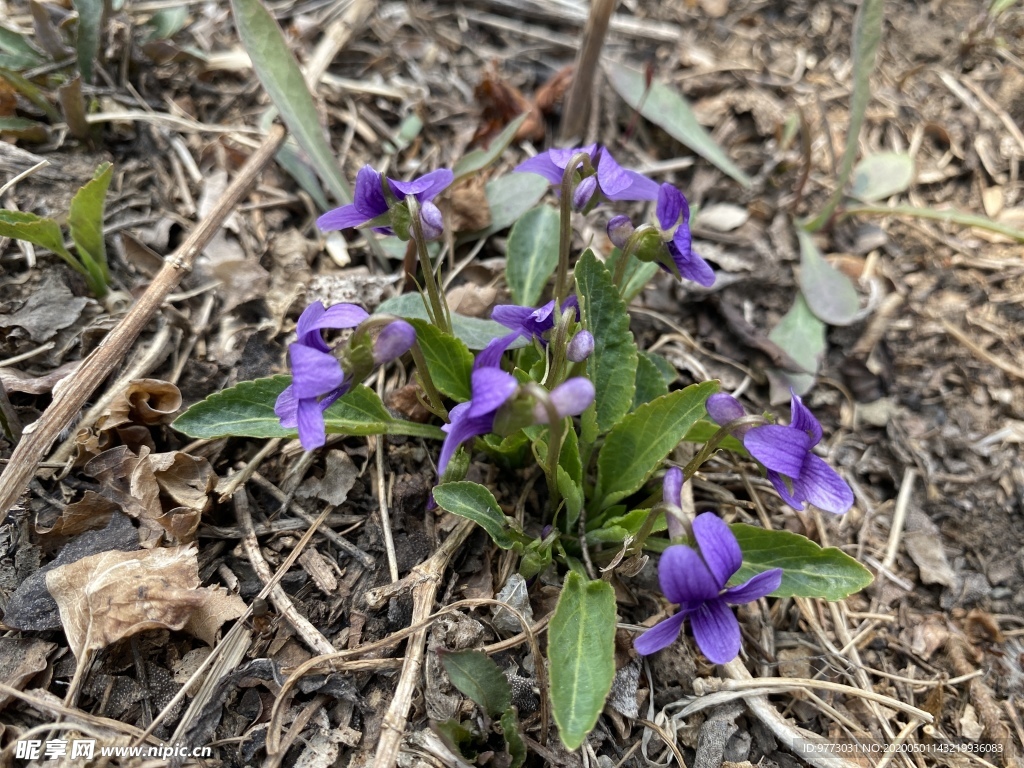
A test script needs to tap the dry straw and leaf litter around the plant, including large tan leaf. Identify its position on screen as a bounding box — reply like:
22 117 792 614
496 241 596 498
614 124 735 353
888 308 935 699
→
0 0 1024 765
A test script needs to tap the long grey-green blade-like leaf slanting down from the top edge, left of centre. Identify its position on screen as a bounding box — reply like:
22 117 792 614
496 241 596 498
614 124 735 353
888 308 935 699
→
231 0 352 203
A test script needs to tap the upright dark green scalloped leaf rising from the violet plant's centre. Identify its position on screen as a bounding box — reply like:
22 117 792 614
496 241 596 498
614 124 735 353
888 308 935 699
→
575 249 637 432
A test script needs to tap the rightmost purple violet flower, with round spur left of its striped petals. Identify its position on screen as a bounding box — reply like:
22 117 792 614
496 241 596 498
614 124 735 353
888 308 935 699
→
707 392 854 515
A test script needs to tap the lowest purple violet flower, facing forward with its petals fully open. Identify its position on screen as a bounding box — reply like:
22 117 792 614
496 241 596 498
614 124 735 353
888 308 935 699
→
633 512 782 664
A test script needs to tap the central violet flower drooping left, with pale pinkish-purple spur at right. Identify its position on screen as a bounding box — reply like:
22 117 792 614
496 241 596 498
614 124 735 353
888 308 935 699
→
437 367 594 476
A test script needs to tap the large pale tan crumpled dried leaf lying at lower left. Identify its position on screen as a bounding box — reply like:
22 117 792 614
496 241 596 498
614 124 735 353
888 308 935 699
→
46 547 206 658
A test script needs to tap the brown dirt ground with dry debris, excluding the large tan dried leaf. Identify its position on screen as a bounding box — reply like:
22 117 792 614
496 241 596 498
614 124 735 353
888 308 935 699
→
0 0 1024 768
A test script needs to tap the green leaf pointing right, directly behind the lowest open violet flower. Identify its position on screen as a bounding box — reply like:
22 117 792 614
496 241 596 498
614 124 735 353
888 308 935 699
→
729 522 871 600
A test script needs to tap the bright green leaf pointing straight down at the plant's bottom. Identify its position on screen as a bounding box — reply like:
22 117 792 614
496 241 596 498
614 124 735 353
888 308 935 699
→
548 571 615 750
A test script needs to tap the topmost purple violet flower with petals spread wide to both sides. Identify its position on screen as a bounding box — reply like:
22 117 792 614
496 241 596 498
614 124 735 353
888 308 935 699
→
514 144 657 208
